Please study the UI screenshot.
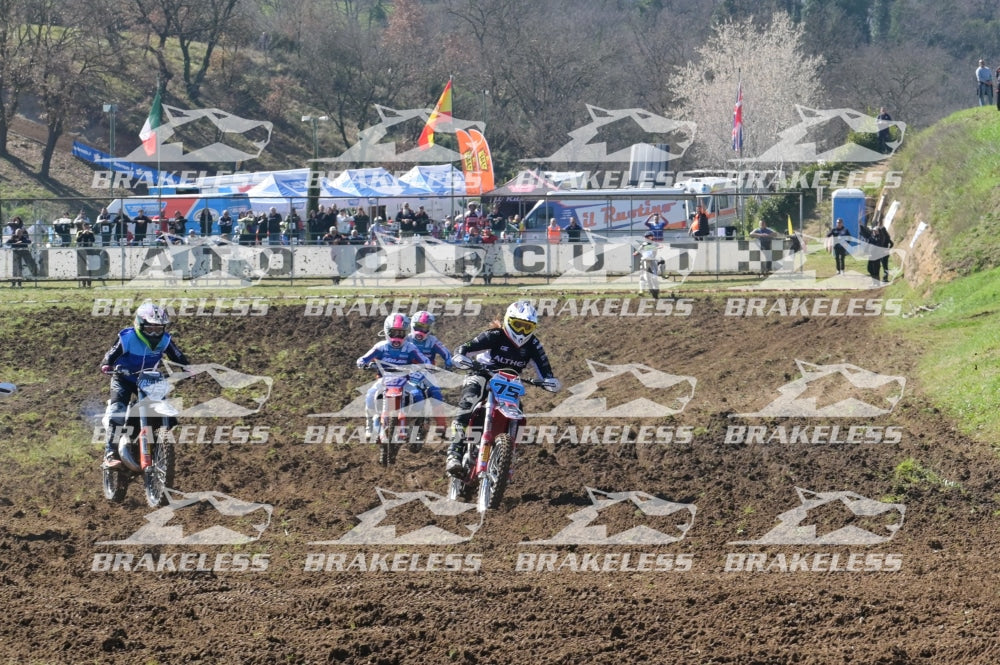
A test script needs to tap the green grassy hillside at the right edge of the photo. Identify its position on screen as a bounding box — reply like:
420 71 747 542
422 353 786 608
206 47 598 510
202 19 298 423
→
889 107 1000 452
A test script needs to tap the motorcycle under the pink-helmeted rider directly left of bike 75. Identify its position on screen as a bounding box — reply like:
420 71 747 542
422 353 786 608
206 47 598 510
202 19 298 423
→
374 362 440 466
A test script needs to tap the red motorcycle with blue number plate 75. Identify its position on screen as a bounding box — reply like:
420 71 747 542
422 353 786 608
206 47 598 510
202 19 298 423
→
448 362 544 513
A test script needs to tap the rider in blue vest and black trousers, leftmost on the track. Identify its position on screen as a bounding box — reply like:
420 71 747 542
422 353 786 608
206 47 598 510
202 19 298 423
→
101 301 189 469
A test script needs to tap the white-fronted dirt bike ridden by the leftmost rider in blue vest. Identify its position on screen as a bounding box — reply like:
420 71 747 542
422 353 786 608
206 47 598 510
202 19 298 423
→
103 368 178 508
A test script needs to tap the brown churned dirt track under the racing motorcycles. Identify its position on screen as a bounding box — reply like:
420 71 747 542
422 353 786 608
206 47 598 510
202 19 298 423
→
0 292 1000 664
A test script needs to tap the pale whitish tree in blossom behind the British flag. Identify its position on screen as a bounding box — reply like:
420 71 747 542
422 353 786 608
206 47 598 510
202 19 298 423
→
670 13 823 167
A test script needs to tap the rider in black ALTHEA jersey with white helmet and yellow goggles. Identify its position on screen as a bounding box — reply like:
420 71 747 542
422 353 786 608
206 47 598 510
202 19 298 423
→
445 300 562 477
